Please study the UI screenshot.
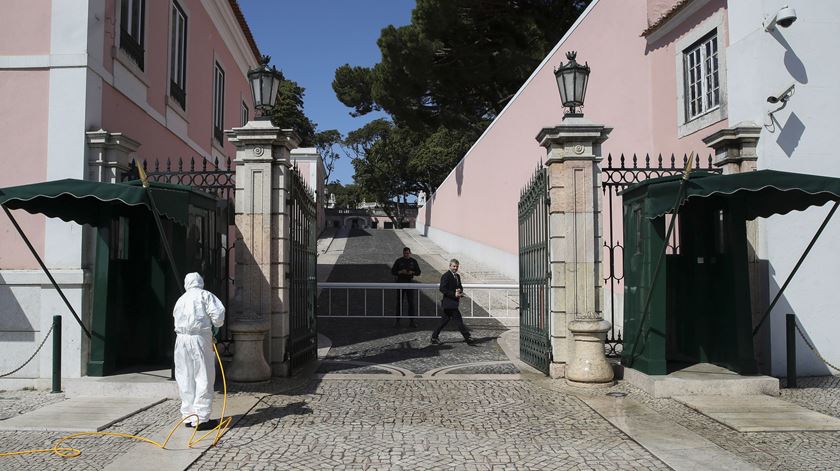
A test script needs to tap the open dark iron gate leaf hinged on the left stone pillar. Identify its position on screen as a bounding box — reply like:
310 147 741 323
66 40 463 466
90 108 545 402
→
288 168 318 369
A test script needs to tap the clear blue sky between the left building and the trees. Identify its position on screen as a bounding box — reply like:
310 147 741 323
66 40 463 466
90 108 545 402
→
239 0 414 184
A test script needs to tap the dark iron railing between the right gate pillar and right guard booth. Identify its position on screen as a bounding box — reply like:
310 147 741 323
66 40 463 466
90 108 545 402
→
601 154 721 356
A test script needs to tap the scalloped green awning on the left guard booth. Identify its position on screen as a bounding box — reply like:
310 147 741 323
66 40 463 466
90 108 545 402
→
0 179 216 226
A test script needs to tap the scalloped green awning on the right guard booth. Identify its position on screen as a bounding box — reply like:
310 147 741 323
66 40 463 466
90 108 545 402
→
620 170 840 220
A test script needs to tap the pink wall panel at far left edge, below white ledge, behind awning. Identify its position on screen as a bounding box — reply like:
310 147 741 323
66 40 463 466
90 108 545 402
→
0 69 50 269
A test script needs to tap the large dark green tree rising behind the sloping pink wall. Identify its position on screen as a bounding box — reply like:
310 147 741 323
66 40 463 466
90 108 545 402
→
333 0 589 206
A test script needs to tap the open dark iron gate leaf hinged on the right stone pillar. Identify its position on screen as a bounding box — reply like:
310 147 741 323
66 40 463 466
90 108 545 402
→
519 166 551 374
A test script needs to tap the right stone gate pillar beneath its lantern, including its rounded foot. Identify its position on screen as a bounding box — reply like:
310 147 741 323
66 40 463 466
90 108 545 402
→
537 117 613 385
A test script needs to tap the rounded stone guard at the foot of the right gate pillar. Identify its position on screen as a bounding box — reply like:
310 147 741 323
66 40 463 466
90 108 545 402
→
566 319 613 387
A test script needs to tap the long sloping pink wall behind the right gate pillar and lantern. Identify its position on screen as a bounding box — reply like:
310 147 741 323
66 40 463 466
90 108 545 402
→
418 0 726 260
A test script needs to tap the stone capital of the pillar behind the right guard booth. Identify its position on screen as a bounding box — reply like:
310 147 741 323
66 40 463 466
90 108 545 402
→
703 121 761 175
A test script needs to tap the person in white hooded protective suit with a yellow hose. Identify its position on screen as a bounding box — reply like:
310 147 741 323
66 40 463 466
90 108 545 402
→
172 273 225 425
